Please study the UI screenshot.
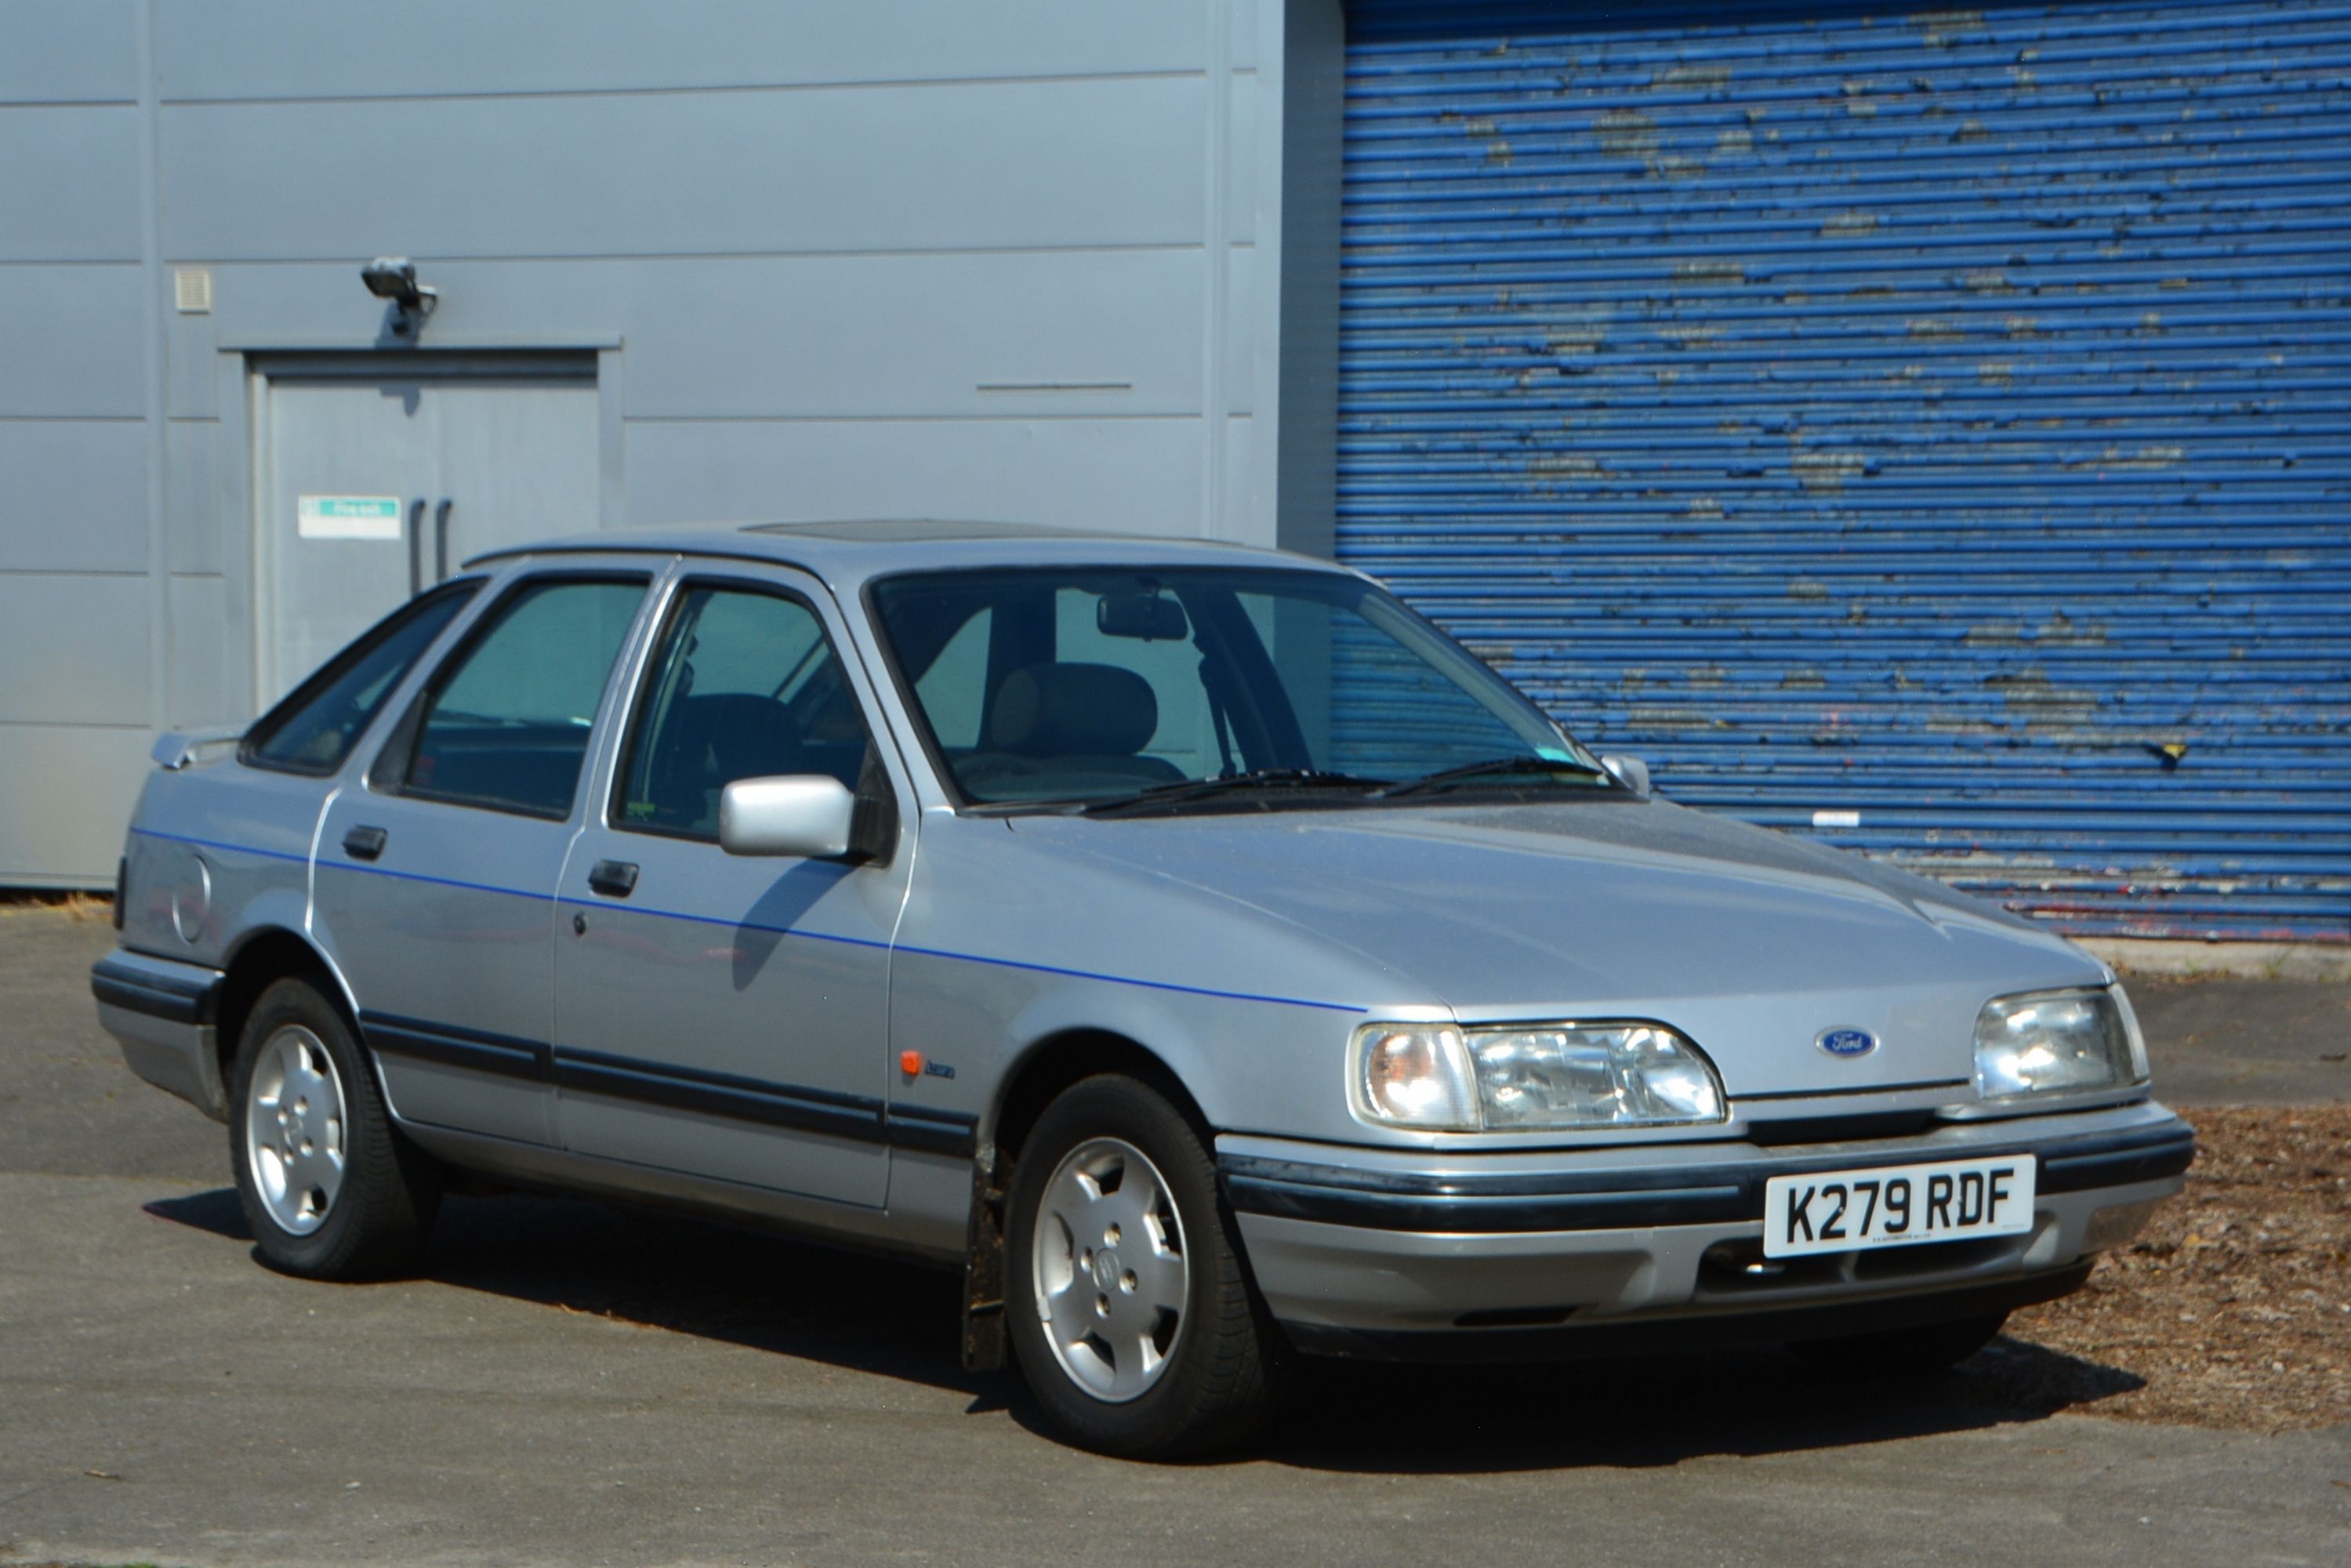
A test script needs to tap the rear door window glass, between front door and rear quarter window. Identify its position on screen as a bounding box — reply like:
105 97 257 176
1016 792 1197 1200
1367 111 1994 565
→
400 579 644 820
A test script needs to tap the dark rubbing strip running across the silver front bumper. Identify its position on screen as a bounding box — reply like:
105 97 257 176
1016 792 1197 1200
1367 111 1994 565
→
1217 1121 2196 1234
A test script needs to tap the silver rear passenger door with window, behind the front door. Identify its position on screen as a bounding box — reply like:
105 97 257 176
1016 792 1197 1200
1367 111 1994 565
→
315 562 658 1142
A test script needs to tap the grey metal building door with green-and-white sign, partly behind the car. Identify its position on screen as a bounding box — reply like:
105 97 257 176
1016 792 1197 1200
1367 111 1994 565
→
254 353 602 708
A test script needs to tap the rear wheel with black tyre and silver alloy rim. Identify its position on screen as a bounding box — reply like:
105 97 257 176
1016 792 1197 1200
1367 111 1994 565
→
228 980 440 1279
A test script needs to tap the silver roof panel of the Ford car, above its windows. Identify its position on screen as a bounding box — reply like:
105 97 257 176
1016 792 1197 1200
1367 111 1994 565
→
466 517 1342 590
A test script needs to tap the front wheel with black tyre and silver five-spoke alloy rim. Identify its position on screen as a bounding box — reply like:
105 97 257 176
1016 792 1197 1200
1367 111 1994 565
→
1004 1074 1279 1460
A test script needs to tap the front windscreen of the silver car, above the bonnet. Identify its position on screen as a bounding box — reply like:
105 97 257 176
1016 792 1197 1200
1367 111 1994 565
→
870 567 1608 806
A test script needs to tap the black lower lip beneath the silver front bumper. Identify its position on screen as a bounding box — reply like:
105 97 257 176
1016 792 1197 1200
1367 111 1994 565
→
1281 1262 2090 1361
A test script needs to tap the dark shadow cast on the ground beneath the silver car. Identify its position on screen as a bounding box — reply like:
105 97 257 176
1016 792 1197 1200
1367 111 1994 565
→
146 1187 2144 1474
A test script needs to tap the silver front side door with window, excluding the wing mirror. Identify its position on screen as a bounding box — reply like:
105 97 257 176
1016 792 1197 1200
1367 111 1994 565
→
555 569 912 1206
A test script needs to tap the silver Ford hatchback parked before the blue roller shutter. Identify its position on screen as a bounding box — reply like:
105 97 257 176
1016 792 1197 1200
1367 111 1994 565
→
92 522 2193 1455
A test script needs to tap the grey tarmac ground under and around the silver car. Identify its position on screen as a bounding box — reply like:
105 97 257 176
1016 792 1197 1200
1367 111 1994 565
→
0 907 2351 1568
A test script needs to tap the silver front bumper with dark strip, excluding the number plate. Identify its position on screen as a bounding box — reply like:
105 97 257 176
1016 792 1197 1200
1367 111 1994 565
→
1217 1102 2196 1359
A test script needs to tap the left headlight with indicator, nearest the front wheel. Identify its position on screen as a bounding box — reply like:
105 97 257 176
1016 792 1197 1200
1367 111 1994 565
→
1347 1022 1723 1133
